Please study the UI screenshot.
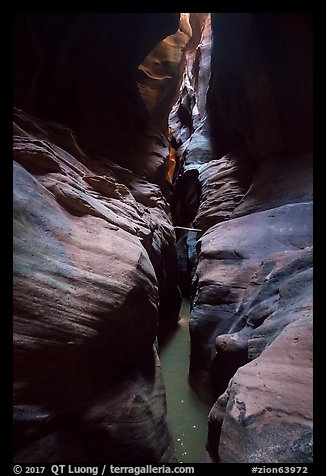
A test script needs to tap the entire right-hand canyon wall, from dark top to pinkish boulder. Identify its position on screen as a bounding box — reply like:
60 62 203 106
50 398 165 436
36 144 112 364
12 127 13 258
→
170 13 312 463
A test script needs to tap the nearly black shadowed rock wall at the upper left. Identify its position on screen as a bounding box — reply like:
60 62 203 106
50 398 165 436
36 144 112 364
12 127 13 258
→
14 13 179 163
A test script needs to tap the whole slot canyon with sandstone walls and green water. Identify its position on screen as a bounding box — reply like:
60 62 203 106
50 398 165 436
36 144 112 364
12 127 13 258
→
13 13 313 464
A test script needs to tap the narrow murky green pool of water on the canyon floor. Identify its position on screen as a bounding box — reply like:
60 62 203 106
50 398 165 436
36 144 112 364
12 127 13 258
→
159 300 210 463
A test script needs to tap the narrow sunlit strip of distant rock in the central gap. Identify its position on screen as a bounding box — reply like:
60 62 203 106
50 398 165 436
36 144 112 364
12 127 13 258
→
169 13 214 297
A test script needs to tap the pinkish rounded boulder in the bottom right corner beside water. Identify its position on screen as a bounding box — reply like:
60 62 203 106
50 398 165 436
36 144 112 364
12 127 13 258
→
209 317 313 463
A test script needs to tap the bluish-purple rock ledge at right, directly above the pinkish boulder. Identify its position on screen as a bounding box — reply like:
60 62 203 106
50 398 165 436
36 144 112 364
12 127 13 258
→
190 202 312 399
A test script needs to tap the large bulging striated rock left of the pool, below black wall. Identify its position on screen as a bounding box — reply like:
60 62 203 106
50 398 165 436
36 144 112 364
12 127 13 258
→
14 111 180 463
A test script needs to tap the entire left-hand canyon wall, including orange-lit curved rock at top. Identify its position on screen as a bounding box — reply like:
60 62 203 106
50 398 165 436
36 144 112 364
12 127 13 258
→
14 13 190 463
